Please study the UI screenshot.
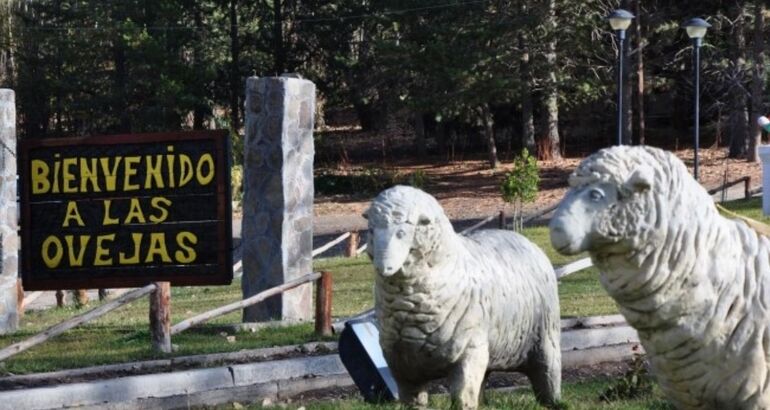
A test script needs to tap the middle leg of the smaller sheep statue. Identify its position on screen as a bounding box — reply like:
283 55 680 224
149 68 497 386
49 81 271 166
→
449 345 489 410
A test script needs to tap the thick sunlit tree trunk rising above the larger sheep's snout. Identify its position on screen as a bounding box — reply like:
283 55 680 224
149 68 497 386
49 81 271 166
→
538 0 561 159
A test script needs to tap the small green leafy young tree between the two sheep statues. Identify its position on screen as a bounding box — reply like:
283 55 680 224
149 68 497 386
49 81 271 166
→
500 148 540 231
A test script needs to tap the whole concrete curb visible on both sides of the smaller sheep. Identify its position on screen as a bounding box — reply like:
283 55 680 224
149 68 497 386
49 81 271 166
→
0 316 643 410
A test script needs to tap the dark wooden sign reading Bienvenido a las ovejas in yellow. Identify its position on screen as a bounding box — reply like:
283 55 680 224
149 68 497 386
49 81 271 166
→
19 131 232 290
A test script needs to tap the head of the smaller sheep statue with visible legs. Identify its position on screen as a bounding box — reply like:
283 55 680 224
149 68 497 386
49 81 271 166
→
364 185 453 277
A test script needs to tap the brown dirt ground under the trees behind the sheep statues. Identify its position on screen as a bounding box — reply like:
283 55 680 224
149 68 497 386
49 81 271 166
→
314 148 762 220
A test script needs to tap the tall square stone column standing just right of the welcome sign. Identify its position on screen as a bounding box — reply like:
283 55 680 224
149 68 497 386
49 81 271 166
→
241 76 315 322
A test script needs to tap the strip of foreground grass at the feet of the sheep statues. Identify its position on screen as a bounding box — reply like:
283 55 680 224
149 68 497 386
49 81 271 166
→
242 378 674 410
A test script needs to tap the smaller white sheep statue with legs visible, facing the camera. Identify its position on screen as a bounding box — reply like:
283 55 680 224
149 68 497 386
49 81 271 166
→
365 186 561 409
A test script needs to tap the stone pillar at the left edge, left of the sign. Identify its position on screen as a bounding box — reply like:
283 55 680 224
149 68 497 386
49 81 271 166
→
0 89 19 334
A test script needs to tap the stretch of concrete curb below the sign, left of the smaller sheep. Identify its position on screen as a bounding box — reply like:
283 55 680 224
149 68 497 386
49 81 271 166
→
0 355 344 410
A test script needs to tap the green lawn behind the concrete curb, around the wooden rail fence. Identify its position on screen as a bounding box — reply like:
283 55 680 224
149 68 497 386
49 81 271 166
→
0 199 756 374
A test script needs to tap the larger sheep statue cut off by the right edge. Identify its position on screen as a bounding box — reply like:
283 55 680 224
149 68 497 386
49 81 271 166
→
550 146 770 409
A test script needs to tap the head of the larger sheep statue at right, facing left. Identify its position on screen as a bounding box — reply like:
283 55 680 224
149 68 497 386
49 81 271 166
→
550 147 700 268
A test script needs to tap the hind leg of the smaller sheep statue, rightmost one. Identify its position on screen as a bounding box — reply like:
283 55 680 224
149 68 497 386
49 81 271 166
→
526 337 561 406
